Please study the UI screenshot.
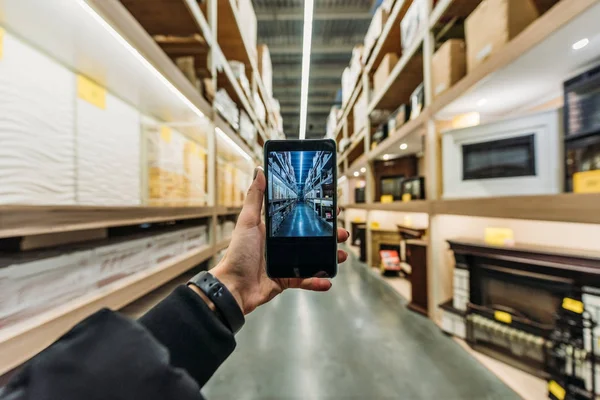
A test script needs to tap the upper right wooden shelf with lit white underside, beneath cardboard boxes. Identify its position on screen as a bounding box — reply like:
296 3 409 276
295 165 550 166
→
431 0 600 120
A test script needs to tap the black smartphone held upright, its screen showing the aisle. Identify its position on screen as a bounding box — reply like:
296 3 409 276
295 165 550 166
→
264 139 337 278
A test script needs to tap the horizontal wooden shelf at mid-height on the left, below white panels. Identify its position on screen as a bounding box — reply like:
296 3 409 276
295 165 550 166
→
0 205 214 238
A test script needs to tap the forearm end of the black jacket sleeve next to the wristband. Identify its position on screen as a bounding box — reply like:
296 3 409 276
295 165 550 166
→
140 285 235 386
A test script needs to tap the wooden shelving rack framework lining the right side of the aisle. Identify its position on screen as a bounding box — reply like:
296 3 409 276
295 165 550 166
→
332 0 600 321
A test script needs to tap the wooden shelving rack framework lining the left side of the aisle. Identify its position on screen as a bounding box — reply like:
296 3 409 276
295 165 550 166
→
0 0 281 375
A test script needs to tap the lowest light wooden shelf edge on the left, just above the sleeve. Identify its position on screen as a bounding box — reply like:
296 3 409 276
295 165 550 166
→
0 247 217 375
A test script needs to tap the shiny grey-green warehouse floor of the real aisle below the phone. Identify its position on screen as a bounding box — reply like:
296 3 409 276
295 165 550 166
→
203 250 519 400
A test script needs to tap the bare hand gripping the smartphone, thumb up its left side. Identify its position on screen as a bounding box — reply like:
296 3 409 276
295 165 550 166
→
210 167 349 314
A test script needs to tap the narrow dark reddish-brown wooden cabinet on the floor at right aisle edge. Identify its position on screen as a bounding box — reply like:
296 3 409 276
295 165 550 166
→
406 239 429 316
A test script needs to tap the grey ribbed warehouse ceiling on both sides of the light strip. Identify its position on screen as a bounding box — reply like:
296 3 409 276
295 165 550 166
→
253 0 376 139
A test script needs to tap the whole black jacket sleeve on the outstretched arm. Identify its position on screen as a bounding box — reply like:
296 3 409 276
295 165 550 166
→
0 286 235 400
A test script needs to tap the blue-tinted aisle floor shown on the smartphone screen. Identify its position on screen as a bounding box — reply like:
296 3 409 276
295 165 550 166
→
277 203 333 237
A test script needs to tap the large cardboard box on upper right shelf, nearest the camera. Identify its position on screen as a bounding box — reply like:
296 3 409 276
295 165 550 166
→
465 0 538 71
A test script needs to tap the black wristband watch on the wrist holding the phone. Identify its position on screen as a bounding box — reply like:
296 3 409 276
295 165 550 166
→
187 271 246 334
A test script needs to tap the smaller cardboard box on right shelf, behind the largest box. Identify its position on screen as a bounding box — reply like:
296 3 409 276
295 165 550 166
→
431 39 467 98
